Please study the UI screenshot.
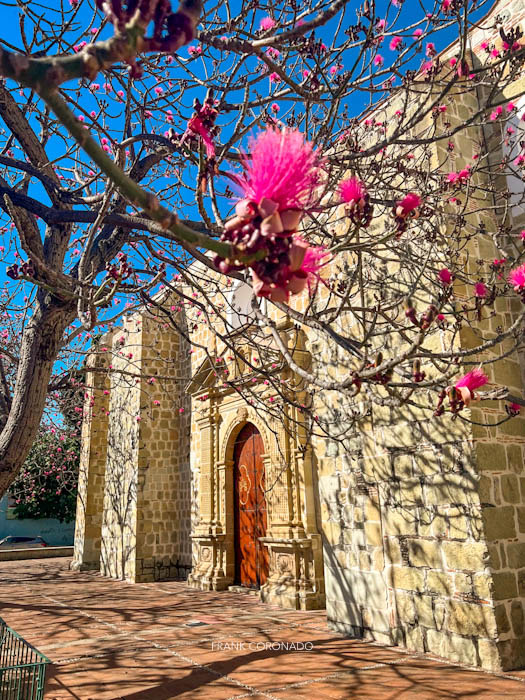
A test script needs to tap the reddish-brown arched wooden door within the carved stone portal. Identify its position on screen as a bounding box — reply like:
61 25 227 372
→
233 423 269 588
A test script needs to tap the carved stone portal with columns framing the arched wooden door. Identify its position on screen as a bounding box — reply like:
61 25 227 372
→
187 342 325 610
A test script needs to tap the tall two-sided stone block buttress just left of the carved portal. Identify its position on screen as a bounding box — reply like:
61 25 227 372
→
96 313 191 582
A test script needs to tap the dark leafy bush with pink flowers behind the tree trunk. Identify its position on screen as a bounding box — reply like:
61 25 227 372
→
10 423 80 522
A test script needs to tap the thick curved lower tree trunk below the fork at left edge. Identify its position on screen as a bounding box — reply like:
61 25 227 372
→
0 299 75 498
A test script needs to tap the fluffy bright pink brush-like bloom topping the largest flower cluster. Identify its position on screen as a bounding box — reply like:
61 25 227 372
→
234 127 320 211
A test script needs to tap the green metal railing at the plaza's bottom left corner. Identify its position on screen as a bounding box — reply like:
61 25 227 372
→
0 618 51 700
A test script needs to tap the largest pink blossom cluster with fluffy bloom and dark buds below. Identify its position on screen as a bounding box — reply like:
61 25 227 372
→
215 128 328 301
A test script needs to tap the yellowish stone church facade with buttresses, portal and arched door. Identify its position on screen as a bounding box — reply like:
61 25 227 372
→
73 0 525 670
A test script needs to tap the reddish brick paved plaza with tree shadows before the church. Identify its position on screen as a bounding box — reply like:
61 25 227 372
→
0 559 525 700
